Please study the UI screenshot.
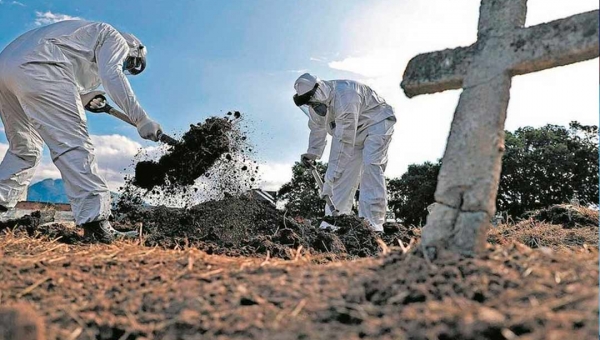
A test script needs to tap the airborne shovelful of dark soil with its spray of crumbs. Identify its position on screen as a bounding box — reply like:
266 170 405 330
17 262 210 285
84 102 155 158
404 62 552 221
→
116 111 259 212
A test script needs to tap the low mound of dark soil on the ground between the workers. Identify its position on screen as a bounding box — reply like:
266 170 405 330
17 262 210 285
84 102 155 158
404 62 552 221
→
115 196 410 259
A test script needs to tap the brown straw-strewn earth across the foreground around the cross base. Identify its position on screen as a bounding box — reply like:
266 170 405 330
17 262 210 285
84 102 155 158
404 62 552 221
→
0 205 598 340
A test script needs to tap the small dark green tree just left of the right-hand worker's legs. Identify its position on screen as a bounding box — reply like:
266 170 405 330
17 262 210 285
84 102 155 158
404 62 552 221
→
277 162 327 219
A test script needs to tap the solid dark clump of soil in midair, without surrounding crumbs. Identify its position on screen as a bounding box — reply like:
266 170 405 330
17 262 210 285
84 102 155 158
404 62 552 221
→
133 117 232 190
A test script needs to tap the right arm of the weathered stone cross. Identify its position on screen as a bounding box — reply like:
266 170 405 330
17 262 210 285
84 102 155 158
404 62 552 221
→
510 10 599 75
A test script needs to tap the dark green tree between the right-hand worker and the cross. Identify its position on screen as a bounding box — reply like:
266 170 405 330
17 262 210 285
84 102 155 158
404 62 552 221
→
388 161 441 225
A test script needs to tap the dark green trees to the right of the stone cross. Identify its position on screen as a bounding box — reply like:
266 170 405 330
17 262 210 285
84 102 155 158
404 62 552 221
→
496 122 598 216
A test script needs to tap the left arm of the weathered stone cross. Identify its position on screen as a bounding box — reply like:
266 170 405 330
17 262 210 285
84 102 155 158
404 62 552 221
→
400 45 476 98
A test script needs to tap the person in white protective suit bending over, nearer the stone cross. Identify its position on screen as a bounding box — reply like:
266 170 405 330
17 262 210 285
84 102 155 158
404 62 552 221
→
294 73 396 231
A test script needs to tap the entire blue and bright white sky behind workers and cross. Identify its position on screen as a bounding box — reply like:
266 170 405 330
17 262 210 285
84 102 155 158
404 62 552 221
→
0 0 600 190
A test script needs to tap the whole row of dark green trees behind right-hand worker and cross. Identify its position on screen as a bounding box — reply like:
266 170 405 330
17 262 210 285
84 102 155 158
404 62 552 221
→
278 122 598 225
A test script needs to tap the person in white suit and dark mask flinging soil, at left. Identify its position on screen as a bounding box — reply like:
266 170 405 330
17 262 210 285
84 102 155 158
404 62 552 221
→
0 20 161 242
